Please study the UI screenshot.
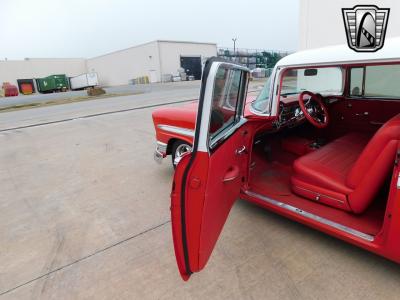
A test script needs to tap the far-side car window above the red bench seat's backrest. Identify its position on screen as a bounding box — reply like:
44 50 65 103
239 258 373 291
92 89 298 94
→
350 65 400 99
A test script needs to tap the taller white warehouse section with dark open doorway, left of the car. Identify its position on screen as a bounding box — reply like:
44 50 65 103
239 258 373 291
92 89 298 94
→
86 40 217 86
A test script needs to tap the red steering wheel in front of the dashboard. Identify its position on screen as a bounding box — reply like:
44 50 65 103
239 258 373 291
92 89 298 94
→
299 91 329 128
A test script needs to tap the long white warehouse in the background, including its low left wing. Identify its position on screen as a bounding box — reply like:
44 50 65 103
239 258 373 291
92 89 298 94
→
0 40 217 86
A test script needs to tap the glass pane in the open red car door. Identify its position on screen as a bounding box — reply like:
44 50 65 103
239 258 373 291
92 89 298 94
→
209 67 242 139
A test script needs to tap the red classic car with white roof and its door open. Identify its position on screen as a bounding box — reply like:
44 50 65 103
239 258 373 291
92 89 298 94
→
153 39 400 280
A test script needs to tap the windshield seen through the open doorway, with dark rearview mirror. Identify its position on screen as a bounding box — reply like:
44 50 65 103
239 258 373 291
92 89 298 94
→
281 67 343 96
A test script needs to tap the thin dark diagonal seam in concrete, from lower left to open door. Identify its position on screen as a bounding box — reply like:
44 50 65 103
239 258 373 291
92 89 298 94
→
0 220 171 296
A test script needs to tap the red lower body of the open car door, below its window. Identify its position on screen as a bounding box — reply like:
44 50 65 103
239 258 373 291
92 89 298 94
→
171 125 250 279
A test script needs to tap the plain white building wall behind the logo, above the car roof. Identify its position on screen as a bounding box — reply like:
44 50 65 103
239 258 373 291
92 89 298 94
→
299 0 400 50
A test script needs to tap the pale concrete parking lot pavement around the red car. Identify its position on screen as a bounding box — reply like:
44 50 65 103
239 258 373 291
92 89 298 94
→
0 83 400 299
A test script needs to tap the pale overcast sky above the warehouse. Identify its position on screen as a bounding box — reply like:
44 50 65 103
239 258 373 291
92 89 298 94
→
0 0 299 60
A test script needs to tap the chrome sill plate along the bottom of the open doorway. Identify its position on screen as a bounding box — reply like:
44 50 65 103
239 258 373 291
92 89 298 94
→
244 191 375 242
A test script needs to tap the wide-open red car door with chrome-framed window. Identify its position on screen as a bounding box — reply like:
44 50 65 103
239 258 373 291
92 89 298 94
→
171 58 251 280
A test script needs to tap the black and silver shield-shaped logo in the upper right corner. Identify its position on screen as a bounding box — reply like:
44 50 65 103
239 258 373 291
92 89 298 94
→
342 5 390 52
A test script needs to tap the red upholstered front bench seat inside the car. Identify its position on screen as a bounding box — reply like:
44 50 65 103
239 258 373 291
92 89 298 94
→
291 114 400 214
